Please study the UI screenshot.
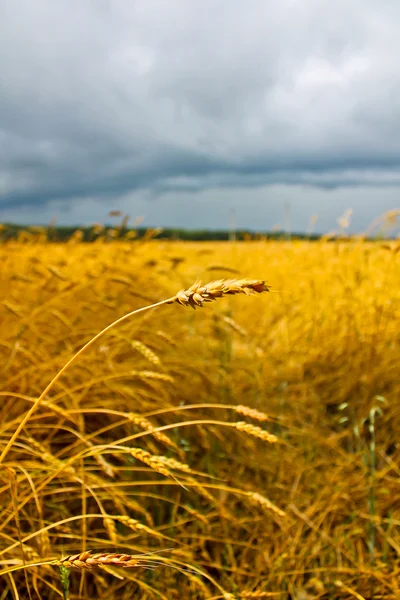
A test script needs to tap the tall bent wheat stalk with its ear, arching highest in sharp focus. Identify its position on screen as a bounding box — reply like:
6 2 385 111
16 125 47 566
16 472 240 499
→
0 279 270 463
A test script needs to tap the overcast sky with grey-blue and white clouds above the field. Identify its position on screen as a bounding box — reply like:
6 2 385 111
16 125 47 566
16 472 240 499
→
0 0 400 231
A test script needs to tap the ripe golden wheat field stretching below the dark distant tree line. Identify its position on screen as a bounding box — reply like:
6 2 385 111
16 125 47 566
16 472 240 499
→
0 234 400 600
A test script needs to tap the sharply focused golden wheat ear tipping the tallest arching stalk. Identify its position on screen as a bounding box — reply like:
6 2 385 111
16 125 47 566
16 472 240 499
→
168 279 270 308
